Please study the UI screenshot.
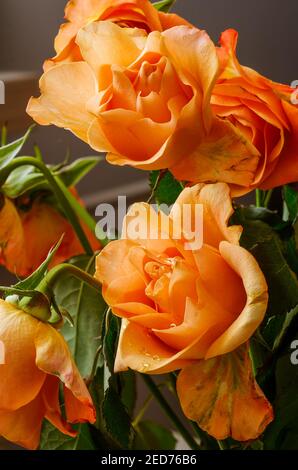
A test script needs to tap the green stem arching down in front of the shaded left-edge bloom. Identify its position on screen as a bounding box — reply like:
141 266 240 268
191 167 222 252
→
0 157 93 255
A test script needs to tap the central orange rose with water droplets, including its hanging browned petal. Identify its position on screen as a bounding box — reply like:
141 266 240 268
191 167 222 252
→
95 183 272 441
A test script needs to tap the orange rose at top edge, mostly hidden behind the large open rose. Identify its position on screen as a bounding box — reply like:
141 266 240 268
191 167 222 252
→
44 0 189 70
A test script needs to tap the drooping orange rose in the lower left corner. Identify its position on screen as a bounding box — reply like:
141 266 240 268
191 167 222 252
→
0 300 95 449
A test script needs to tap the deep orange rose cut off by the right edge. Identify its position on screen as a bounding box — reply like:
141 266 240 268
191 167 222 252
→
212 29 298 194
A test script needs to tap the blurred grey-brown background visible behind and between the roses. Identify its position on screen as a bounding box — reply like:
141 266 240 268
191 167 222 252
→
0 0 298 449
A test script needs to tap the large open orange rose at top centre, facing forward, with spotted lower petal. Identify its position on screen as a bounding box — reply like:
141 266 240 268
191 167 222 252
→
27 21 259 185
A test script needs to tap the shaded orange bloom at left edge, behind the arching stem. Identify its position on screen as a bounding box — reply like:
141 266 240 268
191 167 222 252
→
0 192 100 277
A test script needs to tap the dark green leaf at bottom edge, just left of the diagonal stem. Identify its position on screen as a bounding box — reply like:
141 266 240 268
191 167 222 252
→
134 421 177 450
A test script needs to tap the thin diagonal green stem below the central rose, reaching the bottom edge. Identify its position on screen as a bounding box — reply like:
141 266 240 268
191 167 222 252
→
142 374 200 450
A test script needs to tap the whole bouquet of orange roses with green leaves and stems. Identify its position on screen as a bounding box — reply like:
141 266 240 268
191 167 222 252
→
0 0 298 449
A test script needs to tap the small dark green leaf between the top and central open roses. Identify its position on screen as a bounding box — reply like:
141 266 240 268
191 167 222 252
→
150 170 183 206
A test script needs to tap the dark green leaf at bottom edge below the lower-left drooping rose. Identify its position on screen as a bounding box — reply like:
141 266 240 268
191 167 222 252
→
39 420 96 450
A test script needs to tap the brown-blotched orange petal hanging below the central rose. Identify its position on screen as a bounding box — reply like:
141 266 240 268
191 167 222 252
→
177 346 273 441
